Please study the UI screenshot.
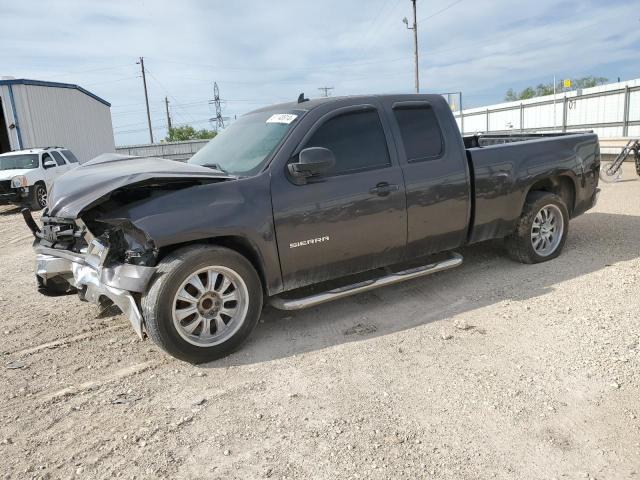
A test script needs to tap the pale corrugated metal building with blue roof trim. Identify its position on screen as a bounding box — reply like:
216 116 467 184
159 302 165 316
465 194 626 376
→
0 77 115 163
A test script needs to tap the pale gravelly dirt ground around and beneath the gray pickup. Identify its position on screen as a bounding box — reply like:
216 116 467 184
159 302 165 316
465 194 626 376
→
0 166 640 480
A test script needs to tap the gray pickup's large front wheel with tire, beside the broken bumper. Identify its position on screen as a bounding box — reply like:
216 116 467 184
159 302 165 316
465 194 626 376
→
141 245 263 363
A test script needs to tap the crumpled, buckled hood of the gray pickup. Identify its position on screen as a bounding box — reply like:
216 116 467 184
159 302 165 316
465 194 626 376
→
47 154 235 218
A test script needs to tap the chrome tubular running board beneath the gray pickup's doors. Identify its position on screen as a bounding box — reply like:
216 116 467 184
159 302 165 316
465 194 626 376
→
269 252 463 310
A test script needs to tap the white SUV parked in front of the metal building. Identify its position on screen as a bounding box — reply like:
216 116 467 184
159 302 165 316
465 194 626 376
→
0 147 79 210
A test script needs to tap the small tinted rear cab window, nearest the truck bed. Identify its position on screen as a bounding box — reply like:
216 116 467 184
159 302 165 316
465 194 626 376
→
393 105 443 162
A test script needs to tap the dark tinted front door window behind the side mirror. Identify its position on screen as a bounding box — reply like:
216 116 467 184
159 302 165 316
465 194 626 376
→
305 110 391 175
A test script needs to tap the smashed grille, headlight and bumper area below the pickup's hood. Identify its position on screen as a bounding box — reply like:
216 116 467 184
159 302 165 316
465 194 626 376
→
30 212 157 338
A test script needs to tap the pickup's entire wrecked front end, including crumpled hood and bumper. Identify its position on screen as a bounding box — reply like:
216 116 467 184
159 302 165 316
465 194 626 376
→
23 154 235 337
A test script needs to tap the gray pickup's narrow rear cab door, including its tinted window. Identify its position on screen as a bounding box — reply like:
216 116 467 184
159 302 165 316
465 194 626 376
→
385 99 471 259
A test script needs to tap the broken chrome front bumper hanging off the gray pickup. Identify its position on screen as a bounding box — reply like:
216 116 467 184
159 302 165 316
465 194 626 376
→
35 245 156 338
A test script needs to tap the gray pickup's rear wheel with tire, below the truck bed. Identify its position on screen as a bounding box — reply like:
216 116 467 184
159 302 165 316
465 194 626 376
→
505 192 569 263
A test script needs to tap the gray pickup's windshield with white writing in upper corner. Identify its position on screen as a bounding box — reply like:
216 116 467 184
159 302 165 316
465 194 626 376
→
189 110 304 176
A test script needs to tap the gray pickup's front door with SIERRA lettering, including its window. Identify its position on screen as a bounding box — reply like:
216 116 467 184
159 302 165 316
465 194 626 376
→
272 105 407 289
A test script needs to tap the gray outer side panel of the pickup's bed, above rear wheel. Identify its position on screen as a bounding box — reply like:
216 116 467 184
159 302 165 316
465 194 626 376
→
464 133 600 243
